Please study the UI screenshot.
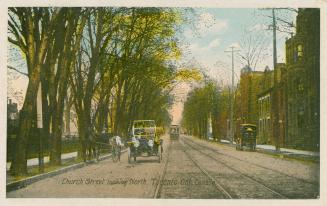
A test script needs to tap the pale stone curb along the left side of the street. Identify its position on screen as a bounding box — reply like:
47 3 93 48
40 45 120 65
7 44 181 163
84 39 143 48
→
6 149 127 192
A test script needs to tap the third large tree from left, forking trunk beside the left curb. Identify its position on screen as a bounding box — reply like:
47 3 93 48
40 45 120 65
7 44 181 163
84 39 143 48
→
70 8 118 161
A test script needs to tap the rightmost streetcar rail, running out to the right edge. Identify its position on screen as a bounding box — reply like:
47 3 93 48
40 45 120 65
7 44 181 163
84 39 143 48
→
183 138 319 186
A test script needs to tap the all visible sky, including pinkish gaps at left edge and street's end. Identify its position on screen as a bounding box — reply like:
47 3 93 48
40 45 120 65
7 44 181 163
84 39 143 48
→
8 8 296 124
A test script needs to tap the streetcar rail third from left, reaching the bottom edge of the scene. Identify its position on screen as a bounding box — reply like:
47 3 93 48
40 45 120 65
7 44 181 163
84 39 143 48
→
183 140 289 199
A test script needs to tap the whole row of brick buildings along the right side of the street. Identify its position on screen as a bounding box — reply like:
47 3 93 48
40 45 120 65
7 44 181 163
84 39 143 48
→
234 9 320 150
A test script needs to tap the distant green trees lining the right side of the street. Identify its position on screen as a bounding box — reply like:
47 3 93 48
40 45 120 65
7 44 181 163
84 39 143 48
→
182 79 240 140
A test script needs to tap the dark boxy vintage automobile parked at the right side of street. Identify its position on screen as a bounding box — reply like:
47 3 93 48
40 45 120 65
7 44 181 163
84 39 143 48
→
236 124 257 151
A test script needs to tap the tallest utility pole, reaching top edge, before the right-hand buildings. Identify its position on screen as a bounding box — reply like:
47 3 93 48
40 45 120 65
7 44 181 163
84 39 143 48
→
272 8 280 151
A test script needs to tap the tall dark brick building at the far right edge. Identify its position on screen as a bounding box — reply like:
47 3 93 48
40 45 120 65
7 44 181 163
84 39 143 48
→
285 9 320 150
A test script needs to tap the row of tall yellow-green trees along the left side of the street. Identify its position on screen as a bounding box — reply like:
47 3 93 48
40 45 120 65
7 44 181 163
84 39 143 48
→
8 8 190 175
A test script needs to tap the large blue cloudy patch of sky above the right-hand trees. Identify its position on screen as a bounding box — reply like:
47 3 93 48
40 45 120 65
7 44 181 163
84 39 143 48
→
178 8 295 82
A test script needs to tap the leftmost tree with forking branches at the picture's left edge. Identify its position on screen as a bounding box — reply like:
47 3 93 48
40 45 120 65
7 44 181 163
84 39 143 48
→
8 7 61 175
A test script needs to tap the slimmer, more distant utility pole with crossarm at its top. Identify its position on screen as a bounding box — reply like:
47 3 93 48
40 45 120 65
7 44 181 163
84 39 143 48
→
225 46 240 144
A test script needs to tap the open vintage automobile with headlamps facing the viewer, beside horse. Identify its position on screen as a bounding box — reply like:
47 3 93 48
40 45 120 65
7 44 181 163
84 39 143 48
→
127 120 163 163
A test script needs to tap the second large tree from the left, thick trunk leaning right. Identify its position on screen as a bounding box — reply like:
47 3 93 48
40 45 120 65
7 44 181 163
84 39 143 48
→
44 8 87 165
